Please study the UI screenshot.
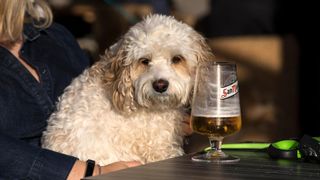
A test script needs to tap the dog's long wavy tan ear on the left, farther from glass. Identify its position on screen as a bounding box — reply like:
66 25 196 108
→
104 40 136 113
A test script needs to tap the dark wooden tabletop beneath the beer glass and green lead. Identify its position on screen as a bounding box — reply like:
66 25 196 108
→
88 150 320 180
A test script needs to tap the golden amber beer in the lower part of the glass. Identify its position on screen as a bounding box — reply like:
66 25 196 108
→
191 116 241 137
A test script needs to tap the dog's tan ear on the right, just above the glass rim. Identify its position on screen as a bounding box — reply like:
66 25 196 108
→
192 33 215 64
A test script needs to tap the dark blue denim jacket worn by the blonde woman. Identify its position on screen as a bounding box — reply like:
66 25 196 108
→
0 24 89 180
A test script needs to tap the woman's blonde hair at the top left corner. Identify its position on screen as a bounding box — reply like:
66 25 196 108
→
0 0 52 43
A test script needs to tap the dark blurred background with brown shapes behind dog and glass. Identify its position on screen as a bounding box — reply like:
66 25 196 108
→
48 0 320 151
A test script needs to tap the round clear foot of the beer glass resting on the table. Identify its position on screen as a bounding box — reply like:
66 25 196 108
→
191 151 240 163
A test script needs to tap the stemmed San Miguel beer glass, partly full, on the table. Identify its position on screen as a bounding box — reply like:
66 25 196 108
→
191 62 241 163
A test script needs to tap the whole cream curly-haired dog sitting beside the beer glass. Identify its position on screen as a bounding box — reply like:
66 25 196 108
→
42 15 213 165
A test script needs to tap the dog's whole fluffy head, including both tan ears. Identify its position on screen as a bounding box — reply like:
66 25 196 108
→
102 15 213 111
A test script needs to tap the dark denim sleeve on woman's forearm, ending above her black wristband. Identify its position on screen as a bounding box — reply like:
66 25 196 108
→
0 132 76 180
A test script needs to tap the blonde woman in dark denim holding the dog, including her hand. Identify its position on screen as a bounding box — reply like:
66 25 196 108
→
0 0 140 180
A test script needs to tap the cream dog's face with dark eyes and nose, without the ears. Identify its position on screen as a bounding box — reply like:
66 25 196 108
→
131 40 196 109
